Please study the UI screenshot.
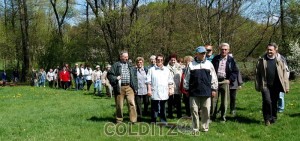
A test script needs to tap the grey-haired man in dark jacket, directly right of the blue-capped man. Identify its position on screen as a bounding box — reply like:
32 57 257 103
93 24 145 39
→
212 43 238 123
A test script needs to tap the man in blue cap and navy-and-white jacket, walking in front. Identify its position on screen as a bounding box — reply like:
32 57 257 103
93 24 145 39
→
184 46 218 132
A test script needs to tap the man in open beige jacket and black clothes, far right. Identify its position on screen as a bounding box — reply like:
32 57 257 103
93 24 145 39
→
255 43 289 126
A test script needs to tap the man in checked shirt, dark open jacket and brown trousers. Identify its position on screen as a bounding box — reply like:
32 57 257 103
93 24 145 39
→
108 51 137 123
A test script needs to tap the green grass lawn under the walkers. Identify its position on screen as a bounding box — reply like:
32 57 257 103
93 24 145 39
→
0 81 300 141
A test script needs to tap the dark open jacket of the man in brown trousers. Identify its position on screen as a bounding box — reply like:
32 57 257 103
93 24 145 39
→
107 61 138 95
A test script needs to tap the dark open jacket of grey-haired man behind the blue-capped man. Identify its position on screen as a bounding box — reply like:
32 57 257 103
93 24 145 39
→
212 55 238 85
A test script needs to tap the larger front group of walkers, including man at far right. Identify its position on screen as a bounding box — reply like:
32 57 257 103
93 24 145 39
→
107 43 289 132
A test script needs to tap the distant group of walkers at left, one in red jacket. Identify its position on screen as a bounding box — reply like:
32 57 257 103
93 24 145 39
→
31 63 113 96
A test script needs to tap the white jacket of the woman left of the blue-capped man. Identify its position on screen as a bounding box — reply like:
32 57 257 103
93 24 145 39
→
146 66 174 100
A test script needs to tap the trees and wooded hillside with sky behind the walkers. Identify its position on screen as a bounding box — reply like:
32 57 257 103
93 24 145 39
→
0 0 300 81
